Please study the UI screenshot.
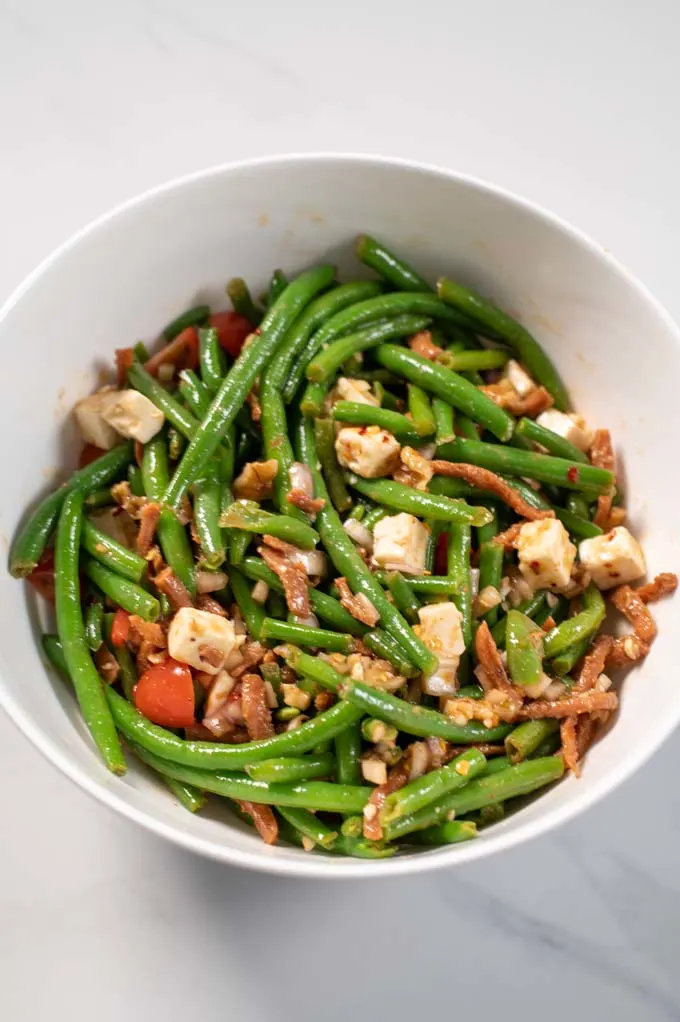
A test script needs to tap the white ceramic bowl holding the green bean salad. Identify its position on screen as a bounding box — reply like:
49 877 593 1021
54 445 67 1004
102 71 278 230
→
0 155 680 877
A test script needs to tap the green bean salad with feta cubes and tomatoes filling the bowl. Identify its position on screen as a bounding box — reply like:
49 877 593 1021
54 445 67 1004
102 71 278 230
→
9 235 677 858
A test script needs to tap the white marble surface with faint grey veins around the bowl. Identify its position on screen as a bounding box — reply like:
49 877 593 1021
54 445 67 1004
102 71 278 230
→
0 0 680 1022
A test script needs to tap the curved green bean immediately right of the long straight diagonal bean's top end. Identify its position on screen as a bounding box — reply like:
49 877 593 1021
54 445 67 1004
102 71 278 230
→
277 280 382 405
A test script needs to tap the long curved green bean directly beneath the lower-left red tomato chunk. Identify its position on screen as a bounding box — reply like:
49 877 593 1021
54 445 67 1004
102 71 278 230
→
106 689 362 771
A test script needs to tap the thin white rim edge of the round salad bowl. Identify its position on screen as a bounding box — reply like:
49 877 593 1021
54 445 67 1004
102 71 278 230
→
0 151 680 879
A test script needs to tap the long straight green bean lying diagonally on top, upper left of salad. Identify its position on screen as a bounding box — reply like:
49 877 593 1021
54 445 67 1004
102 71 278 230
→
165 266 334 507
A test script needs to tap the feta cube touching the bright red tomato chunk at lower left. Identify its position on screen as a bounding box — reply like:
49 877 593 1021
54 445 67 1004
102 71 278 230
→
168 607 245 675
